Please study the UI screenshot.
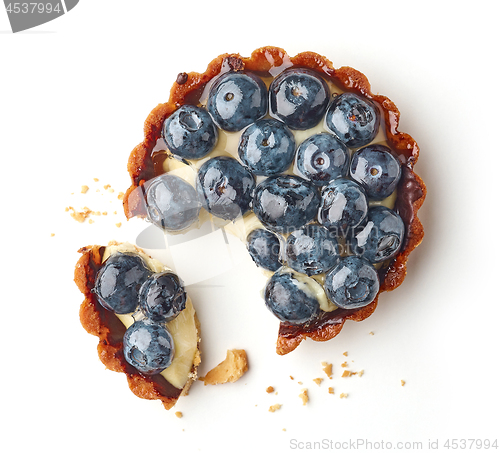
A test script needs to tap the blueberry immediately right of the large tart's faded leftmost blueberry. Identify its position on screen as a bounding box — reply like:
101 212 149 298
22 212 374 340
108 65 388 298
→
196 156 255 220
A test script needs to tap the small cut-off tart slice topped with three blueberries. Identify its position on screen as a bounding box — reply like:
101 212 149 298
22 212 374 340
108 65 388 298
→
75 243 200 409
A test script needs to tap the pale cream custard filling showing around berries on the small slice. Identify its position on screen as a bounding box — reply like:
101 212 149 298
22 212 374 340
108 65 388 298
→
102 243 198 389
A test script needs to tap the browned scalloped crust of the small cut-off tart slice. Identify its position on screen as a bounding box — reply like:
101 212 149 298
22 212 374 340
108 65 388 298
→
75 244 200 409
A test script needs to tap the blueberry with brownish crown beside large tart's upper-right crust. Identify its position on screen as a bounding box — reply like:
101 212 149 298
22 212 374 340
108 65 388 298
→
325 93 380 148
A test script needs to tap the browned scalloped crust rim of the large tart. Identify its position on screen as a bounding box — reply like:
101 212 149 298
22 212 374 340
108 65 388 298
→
124 46 427 355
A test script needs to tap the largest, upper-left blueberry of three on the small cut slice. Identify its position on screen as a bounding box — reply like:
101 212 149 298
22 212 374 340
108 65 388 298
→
93 253 151 315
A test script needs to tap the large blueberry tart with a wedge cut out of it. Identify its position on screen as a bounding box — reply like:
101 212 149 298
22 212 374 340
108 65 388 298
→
124 47 426 355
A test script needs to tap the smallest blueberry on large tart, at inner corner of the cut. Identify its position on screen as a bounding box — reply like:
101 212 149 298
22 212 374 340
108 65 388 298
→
247 228 282 271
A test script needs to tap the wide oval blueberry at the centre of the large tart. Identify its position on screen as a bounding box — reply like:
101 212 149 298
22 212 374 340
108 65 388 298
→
253 175 319 233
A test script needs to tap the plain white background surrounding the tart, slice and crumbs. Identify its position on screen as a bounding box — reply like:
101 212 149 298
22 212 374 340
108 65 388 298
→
0 0 500 452
